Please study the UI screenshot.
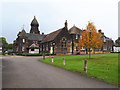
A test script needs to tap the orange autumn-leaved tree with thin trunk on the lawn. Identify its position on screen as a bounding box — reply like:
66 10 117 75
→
78 22 103 58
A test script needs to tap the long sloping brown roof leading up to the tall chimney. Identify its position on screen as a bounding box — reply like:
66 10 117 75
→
41 28 64 43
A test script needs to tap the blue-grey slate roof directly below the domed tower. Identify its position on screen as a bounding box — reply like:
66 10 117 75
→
27 33 45 41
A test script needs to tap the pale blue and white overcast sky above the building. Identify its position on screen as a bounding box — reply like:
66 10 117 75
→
0 0 119 43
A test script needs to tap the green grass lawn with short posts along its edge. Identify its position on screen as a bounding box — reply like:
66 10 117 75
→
40 54 120 85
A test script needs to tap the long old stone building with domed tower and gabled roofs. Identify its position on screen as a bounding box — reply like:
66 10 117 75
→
13 17 113 54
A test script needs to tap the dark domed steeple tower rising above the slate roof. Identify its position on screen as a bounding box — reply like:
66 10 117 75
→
30 16 40 34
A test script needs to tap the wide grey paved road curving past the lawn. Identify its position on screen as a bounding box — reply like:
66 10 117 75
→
2 56 116 88
